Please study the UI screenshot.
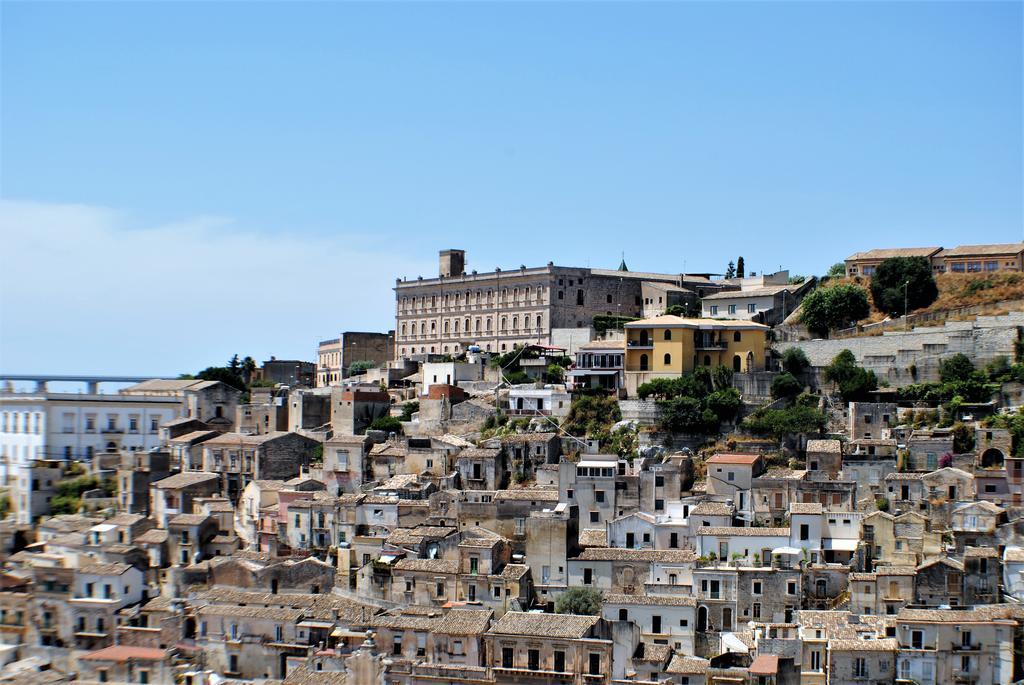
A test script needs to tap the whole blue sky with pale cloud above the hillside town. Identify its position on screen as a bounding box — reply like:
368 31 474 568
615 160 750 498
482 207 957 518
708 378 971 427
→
0 2 1024 374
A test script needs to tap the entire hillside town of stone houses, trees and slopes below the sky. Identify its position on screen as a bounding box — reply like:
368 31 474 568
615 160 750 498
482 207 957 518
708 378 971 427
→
6 243 1024 685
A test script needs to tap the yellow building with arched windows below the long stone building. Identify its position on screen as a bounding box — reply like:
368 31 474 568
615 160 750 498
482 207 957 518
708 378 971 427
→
626 314 768 396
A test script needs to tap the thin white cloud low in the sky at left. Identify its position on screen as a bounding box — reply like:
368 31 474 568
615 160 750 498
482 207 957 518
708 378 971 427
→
0 201 435 374
